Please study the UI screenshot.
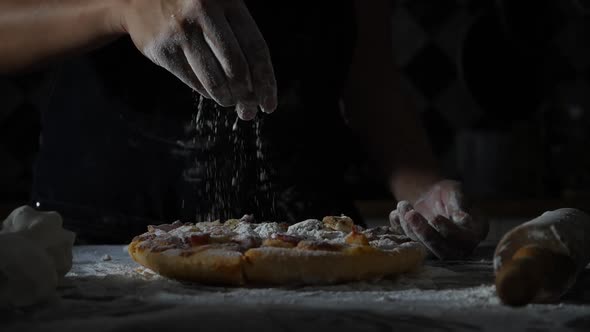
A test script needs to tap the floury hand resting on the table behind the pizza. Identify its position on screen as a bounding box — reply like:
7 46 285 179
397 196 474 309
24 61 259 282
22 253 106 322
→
389 180 489 259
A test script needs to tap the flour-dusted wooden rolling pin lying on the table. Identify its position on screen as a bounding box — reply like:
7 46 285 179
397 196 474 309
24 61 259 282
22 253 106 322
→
494 208 590 306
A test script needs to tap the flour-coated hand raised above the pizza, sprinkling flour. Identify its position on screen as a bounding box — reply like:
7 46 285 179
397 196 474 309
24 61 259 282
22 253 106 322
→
118 0 277 120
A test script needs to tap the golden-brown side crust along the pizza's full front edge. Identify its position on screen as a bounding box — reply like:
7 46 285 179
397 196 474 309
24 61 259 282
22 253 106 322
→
128 240 426 286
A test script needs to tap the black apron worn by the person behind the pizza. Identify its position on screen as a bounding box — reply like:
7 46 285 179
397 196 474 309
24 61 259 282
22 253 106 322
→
32 1 359 243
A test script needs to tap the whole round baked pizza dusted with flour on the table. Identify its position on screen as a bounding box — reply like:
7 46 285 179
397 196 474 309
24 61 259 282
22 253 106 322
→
128 216 426 285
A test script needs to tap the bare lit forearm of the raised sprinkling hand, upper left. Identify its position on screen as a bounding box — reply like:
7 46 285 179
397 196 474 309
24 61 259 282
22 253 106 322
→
0 0 123 73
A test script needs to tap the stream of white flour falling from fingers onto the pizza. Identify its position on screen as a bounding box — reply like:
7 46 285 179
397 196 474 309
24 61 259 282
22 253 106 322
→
187 96 275 221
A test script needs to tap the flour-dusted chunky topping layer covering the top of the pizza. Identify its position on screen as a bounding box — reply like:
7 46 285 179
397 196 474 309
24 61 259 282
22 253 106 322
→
138 215 409 255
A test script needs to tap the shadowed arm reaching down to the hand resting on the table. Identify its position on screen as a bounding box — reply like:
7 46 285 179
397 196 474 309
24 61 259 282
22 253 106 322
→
345 0 440 202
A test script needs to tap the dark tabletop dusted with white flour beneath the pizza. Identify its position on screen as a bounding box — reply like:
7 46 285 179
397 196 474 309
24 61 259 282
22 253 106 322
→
0 246 590 332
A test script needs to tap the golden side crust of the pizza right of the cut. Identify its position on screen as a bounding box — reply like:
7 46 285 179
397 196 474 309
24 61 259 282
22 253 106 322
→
243 243 426 285
